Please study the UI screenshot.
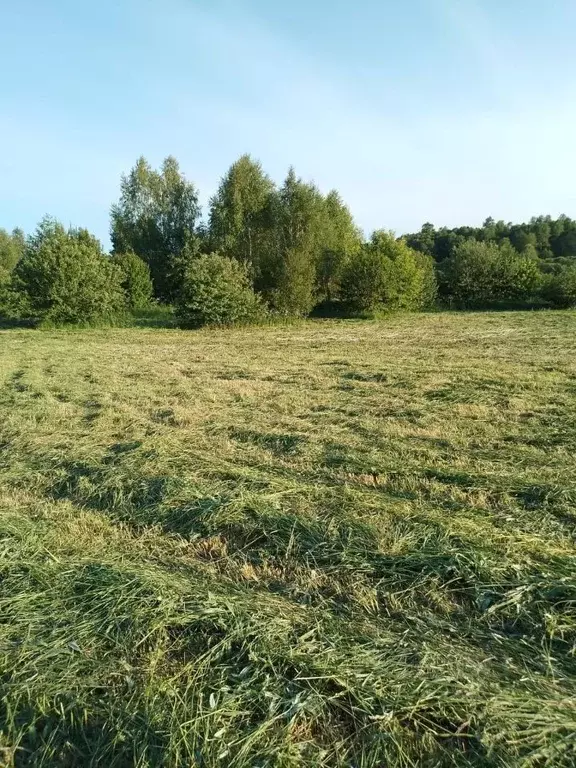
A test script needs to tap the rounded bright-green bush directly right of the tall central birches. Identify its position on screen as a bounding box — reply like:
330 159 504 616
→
341 231 436 311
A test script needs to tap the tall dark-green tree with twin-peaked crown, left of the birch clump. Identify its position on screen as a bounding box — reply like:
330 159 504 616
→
112 157 200 301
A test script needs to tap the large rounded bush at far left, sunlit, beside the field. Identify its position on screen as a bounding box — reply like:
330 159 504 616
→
12 219 126 324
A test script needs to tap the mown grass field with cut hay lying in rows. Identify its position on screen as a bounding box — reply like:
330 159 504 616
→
0 312 576 768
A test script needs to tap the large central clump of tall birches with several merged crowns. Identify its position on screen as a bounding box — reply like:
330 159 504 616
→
209 164 362 315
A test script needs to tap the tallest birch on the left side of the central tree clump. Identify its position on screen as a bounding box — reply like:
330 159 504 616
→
209 155 274 273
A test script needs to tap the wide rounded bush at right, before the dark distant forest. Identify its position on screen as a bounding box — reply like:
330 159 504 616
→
440 240 541 307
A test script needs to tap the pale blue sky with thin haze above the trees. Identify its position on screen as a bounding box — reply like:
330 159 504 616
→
0 0 576 244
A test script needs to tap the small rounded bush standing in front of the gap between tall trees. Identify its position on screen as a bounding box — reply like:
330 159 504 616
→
175 253 266 328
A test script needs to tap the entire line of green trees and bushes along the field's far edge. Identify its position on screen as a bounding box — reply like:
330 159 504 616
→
0 155 576 327
